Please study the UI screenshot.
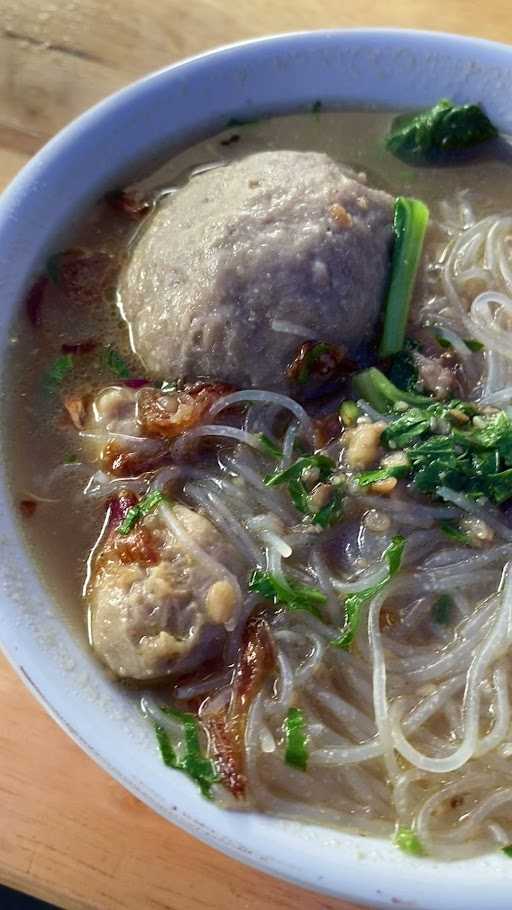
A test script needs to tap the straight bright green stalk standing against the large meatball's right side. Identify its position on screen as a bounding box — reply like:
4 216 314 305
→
379 196 429 357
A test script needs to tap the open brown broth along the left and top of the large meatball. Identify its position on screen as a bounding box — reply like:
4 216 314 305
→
3 112 512 629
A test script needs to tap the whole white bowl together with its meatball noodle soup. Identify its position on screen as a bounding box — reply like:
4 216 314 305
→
0 30 512 910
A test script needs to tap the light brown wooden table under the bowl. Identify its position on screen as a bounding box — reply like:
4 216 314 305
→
0 0 512 910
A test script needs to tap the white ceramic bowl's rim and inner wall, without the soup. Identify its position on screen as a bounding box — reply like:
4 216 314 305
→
0 30 512 910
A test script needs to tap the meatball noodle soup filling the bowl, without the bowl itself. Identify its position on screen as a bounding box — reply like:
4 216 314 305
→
5 107 512 862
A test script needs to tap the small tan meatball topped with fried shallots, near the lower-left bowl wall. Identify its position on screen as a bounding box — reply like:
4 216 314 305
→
88 505 243 682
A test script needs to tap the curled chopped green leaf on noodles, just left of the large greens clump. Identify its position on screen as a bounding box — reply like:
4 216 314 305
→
264 455 343 528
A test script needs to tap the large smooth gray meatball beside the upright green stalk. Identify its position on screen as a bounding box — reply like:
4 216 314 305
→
120 151 393 390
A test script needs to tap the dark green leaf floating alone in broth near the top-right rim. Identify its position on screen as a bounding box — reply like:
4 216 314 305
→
386 98 498 161
